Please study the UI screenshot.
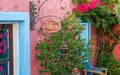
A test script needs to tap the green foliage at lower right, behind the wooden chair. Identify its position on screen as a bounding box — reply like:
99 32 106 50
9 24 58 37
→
97 41 120 75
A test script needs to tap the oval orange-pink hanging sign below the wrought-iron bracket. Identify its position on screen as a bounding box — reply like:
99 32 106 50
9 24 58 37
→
42 20 61 33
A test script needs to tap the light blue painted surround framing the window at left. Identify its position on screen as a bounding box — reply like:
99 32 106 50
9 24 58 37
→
0 12 30 75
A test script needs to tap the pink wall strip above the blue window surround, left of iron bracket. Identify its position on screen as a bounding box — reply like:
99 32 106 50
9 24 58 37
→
0 0 29 12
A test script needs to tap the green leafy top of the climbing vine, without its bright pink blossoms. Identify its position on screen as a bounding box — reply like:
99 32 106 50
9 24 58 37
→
73 0 120 35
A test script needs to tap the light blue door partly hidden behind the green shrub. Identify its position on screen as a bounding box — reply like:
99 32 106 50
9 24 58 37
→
80 21 91 75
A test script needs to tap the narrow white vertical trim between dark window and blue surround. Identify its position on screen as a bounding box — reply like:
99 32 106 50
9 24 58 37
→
13 23 19 75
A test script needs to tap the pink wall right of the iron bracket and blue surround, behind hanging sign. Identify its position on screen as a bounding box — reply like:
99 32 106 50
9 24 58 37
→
31 0 73 75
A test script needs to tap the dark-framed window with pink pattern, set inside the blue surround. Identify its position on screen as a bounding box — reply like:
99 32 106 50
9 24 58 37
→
0 24 13 75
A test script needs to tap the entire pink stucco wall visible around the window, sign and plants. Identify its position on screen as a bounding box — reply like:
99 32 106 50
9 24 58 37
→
0 0 120 75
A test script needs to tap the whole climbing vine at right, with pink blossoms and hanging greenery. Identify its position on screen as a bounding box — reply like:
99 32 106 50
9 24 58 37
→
72 0 120 75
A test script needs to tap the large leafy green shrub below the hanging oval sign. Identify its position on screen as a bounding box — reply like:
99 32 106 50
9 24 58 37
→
36 14 90 75
